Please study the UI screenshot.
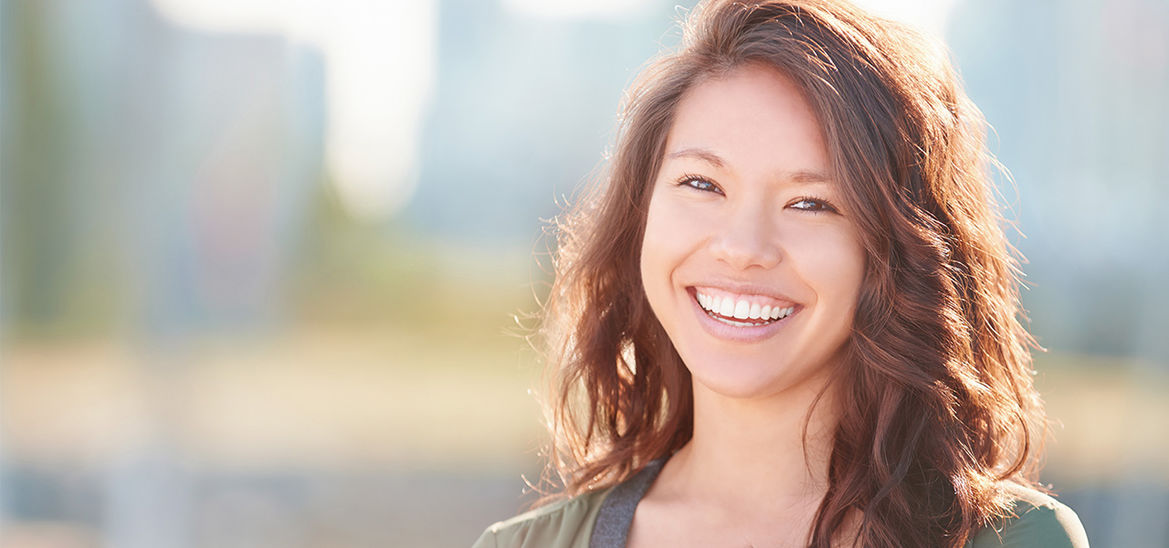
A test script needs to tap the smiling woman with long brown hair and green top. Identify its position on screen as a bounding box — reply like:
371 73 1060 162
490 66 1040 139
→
476 0 1087 547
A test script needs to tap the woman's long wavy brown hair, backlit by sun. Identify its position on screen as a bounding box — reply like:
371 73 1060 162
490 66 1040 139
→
541 0 1046 547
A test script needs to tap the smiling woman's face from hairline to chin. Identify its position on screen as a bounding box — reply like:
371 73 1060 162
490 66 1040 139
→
641 65 865 397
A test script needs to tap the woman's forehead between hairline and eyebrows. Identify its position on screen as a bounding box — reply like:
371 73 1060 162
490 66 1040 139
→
665 64 830 178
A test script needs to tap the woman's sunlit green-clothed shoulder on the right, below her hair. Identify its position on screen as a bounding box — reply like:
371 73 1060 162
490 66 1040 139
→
969 485 1088 548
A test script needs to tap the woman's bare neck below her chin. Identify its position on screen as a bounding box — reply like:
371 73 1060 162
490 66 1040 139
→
663 373 837 508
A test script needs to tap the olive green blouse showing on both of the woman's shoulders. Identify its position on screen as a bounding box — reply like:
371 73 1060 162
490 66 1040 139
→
472 466 1088 548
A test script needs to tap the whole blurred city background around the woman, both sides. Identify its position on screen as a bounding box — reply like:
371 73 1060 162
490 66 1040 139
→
0 0 1169 548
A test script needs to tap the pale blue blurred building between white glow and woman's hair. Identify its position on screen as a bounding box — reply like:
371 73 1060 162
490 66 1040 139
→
406 0 693 245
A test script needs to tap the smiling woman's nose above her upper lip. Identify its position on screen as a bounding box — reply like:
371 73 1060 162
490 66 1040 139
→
711 207 783 270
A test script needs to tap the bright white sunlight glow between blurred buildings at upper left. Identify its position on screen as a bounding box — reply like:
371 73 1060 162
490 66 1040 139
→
152 0 437 221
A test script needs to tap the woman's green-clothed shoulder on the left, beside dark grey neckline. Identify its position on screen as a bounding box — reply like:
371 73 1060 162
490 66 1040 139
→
472 487 613 548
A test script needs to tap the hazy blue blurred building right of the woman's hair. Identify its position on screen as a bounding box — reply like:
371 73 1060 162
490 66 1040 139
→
947 0 1169 366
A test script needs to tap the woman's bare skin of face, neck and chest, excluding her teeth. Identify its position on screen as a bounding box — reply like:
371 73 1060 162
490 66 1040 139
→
629 61 865 547
